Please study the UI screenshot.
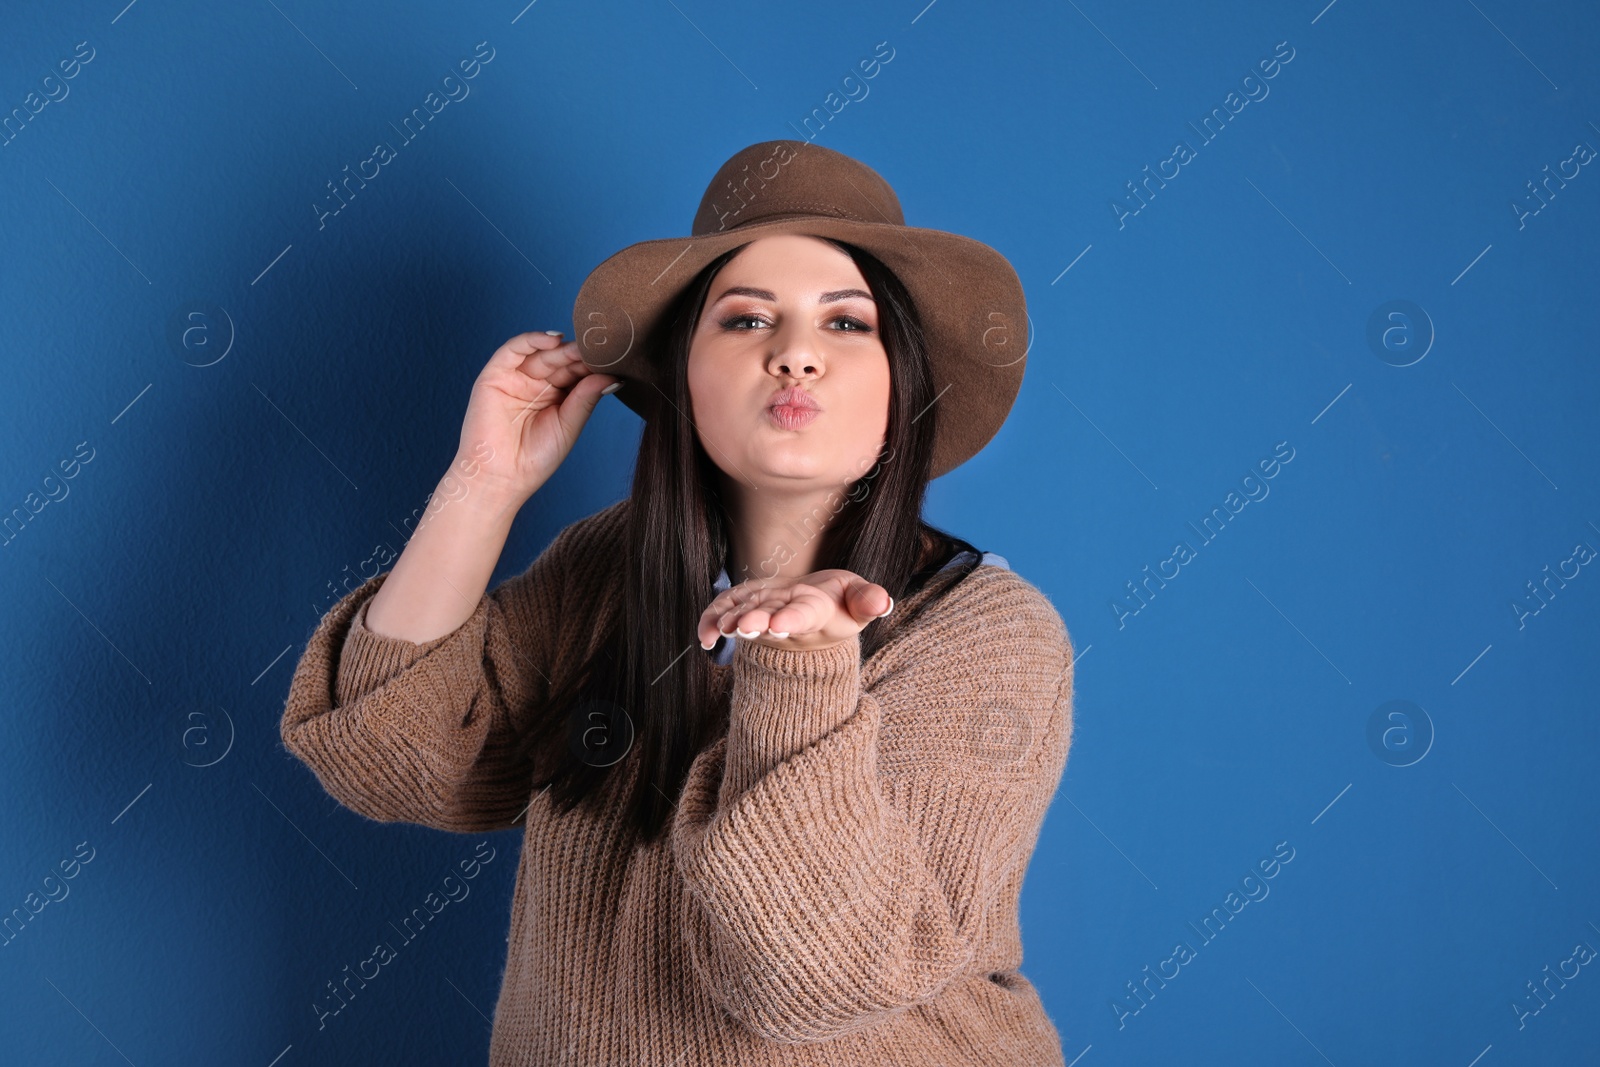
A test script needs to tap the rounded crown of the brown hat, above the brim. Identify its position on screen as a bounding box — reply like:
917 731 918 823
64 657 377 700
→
690 141 906 237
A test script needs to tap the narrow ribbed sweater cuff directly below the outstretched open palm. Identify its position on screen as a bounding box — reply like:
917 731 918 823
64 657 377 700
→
720 635 861 806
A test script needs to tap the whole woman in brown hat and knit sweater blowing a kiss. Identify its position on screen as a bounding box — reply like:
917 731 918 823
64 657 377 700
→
282 141 1072 1065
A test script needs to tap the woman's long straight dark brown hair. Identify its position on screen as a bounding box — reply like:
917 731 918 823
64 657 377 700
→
523 238 976 841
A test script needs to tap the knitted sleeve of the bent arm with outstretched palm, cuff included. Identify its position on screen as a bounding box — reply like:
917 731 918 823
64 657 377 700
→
672 579 1072 1043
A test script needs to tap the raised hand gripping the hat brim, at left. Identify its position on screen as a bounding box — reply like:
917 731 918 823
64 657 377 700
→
454 333 622 507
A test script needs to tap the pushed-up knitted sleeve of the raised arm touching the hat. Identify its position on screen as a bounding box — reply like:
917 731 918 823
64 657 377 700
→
280 511 598 833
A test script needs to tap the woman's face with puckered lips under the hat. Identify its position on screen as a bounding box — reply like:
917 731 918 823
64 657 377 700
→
688 234 890 491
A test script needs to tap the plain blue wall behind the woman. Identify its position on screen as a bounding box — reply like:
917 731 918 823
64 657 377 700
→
0 0 1600 1067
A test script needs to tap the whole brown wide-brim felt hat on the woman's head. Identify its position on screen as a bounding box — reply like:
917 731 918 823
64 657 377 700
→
573 141 1032 478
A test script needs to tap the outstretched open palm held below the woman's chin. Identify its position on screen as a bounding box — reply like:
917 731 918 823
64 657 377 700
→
696 569 894 651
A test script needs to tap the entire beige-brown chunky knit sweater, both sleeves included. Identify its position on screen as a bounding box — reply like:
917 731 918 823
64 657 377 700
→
282 499 1072 1067
